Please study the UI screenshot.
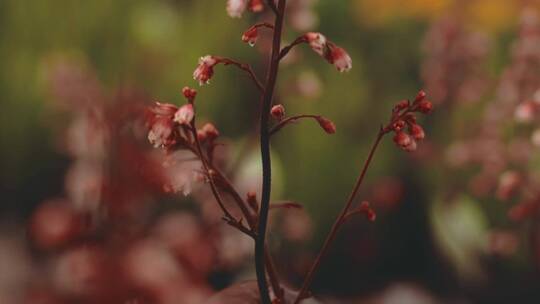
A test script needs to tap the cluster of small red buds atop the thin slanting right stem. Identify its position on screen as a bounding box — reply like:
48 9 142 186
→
384 91 433 152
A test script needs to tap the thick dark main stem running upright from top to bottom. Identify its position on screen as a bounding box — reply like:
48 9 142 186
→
255 0 286 304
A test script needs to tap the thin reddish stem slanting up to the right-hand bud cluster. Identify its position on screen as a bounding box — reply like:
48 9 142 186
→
294 128 388 304
